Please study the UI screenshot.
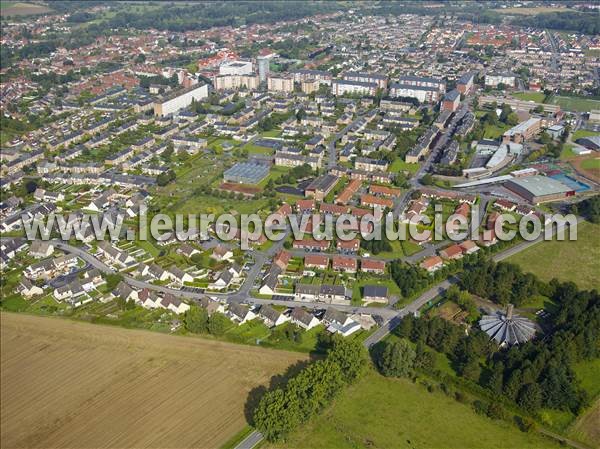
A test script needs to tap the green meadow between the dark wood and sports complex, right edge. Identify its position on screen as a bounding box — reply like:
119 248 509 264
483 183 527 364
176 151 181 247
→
508 221 600 289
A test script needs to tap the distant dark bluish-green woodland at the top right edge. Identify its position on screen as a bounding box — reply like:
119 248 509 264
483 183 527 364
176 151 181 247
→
512 11 600 35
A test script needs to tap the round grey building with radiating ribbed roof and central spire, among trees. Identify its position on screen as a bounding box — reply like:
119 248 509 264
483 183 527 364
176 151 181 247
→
479 304 536 346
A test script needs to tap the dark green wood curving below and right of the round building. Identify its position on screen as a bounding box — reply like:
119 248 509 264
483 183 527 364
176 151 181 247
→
386 264 600 414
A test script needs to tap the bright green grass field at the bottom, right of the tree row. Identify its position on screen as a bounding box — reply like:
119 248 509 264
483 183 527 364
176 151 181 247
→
267 372 559 449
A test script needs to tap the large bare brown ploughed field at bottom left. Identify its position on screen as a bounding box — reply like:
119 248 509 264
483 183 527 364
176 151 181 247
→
0 313 306 448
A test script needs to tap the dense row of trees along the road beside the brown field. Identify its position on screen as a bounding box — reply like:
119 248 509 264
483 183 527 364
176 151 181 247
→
253 336 368 441
